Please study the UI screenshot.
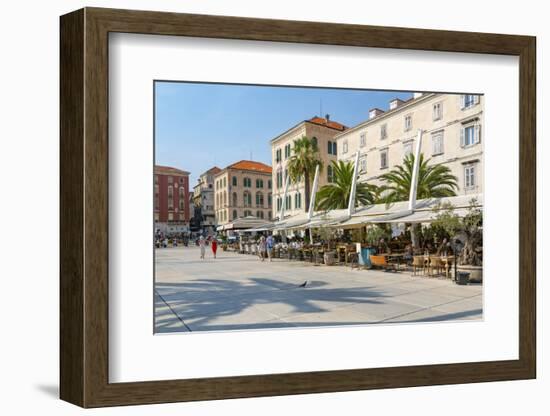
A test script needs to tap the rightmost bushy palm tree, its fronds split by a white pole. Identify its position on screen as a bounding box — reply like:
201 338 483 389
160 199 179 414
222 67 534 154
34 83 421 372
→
380 153 458 205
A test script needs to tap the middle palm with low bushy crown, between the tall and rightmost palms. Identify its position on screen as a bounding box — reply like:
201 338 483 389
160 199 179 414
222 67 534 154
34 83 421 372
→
317 160 378 210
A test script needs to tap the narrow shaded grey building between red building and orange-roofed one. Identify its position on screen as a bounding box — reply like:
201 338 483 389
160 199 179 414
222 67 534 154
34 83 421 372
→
193 166 221 233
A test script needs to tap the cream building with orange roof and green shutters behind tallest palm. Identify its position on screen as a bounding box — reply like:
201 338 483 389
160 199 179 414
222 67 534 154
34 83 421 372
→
271 114 347 218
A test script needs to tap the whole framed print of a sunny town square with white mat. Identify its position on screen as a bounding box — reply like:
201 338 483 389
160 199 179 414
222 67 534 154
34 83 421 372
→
60 8 536 407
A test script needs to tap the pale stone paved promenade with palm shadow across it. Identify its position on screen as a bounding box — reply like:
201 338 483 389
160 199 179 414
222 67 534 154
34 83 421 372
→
155 247 482 333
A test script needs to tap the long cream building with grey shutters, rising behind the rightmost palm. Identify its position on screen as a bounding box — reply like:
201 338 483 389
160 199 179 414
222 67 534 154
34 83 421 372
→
336 93 483 195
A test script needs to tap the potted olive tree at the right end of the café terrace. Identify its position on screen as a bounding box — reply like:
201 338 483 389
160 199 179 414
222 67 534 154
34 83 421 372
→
432 198 483 283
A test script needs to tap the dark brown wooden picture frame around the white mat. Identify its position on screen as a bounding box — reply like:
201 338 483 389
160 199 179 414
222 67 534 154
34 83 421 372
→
60 8 536 407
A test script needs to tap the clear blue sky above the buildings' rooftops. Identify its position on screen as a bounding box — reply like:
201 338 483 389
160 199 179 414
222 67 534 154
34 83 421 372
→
155 82 412 186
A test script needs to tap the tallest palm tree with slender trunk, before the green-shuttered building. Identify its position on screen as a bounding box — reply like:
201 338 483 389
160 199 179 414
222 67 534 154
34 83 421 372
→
287 136 323 211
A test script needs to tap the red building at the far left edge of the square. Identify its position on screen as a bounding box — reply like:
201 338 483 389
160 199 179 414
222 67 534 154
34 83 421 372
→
154 165 189 233
